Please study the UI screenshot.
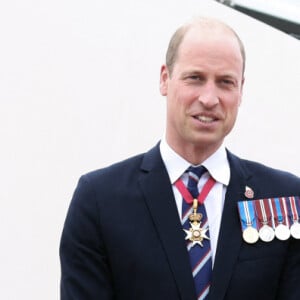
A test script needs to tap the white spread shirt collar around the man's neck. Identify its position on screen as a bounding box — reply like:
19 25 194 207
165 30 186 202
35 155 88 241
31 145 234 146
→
160 139 230 186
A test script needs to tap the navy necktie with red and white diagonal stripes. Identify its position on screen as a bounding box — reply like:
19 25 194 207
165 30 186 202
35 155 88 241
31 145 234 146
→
182 166 212 300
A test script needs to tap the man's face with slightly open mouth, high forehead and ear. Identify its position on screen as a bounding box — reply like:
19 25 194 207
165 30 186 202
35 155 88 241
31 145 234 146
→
160 27 243 157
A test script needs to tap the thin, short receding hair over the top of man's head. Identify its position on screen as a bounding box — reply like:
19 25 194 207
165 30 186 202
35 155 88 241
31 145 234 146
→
166 17 246 74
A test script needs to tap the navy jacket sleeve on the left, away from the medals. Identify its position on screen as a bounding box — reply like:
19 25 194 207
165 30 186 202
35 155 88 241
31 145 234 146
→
60 176 113 300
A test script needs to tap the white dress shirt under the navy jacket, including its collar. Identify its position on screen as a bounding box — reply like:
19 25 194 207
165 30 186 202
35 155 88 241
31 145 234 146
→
160 139 230 263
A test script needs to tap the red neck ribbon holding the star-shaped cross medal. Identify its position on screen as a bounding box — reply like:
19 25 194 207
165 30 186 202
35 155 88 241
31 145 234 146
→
175 177 216 204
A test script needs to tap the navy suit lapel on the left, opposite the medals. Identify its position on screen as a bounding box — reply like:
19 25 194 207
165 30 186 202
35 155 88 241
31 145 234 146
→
139 147 196 300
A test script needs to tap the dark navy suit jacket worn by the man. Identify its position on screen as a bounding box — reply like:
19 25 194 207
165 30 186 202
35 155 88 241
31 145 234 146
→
60 146 300 300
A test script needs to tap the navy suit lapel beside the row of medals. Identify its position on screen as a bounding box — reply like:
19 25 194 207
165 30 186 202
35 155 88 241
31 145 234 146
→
209 152 251 300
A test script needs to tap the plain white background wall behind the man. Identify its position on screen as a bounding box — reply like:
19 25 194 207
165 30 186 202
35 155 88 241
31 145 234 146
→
0 0 300 300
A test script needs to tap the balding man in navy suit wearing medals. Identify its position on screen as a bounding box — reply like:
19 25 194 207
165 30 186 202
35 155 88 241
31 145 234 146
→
60 19 300 300
